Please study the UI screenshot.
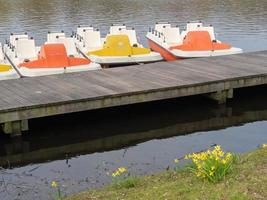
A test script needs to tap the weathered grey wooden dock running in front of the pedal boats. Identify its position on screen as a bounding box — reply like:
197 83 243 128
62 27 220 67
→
0 51 267 135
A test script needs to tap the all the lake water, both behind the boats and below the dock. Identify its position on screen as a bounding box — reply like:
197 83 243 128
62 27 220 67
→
0 0 267 200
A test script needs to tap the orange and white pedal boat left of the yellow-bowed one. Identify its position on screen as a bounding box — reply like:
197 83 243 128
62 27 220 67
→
4 32 101 77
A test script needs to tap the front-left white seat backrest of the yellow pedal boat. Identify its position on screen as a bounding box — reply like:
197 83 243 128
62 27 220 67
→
84 31 102 50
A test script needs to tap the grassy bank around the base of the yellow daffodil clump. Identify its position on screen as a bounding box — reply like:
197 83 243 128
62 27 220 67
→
67 148 267 200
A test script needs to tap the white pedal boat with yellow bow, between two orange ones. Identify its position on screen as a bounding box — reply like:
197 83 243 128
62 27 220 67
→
74 25 162 65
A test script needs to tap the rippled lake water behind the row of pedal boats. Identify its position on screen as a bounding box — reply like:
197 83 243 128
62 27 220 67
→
0 0 267 51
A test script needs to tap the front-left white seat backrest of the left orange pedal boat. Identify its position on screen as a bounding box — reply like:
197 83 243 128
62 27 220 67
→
16 39 36 59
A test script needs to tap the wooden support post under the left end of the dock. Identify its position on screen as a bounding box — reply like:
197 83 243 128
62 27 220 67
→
2 119 29 137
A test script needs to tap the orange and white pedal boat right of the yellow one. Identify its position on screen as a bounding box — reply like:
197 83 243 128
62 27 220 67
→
146 22 242 61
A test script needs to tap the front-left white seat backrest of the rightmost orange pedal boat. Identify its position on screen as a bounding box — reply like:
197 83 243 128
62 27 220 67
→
163 27 183 45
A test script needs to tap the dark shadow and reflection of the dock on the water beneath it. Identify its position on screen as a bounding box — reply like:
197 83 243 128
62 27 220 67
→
0 86 267 167
